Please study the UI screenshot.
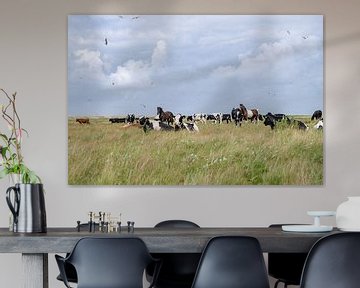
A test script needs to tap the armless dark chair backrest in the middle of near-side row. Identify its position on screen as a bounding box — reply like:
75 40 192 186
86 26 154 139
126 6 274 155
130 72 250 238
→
192 236 269 288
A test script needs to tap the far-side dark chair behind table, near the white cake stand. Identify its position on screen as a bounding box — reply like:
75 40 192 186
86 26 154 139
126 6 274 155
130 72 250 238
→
268 224 307 288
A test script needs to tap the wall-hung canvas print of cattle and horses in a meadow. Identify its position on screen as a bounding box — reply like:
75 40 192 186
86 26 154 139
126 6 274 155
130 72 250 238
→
67 15 325 186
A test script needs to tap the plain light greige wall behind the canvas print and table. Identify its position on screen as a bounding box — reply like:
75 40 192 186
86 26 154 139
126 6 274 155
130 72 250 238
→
0 0 360 287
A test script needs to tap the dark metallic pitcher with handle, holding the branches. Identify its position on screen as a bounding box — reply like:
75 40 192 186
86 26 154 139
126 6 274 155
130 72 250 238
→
6 184 47 233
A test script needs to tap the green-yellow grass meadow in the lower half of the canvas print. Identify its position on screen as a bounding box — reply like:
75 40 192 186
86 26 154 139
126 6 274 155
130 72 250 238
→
68 116 323 185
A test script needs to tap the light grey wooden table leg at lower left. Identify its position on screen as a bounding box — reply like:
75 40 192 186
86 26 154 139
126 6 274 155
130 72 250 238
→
22 253 49 288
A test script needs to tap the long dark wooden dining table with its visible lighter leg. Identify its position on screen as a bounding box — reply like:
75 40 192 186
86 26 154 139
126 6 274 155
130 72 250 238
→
0 227 339 288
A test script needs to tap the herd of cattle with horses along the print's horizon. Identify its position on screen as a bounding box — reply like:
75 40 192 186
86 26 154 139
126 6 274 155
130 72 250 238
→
75 104 324 132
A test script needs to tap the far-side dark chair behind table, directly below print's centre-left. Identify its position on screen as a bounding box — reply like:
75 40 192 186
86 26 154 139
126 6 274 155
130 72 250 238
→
147 220 201 288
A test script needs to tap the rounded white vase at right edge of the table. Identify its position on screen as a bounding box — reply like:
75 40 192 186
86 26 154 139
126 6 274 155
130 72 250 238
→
336 196 360 231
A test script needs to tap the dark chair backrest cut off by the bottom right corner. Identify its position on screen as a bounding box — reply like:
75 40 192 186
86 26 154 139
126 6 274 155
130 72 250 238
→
300 232 360 288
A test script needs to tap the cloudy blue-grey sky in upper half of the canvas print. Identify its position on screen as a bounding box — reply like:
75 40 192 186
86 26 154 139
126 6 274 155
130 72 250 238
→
68 15 324 116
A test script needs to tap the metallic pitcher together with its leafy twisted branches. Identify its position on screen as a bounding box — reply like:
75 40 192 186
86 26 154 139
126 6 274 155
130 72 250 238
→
0 88 47 233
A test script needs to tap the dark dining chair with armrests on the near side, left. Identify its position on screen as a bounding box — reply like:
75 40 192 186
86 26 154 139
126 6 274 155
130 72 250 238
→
55 237 160 288
